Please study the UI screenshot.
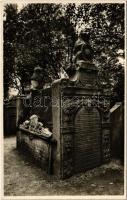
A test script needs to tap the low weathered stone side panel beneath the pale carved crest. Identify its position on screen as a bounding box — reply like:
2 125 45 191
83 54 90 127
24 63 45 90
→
17 130 52 171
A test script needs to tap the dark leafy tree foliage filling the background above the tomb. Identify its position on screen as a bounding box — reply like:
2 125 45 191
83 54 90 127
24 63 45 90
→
4 4 124 104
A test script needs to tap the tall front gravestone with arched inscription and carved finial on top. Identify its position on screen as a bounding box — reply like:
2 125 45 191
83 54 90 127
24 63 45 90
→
52 30 110 178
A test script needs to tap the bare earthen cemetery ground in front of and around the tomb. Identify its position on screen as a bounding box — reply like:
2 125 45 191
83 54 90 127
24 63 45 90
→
4 136 124 196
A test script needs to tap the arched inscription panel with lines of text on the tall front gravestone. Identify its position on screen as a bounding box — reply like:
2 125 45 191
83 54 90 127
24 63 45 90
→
74 107 101 172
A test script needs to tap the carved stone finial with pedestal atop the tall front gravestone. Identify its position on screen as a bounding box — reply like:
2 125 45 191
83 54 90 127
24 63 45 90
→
66 31 97 88
